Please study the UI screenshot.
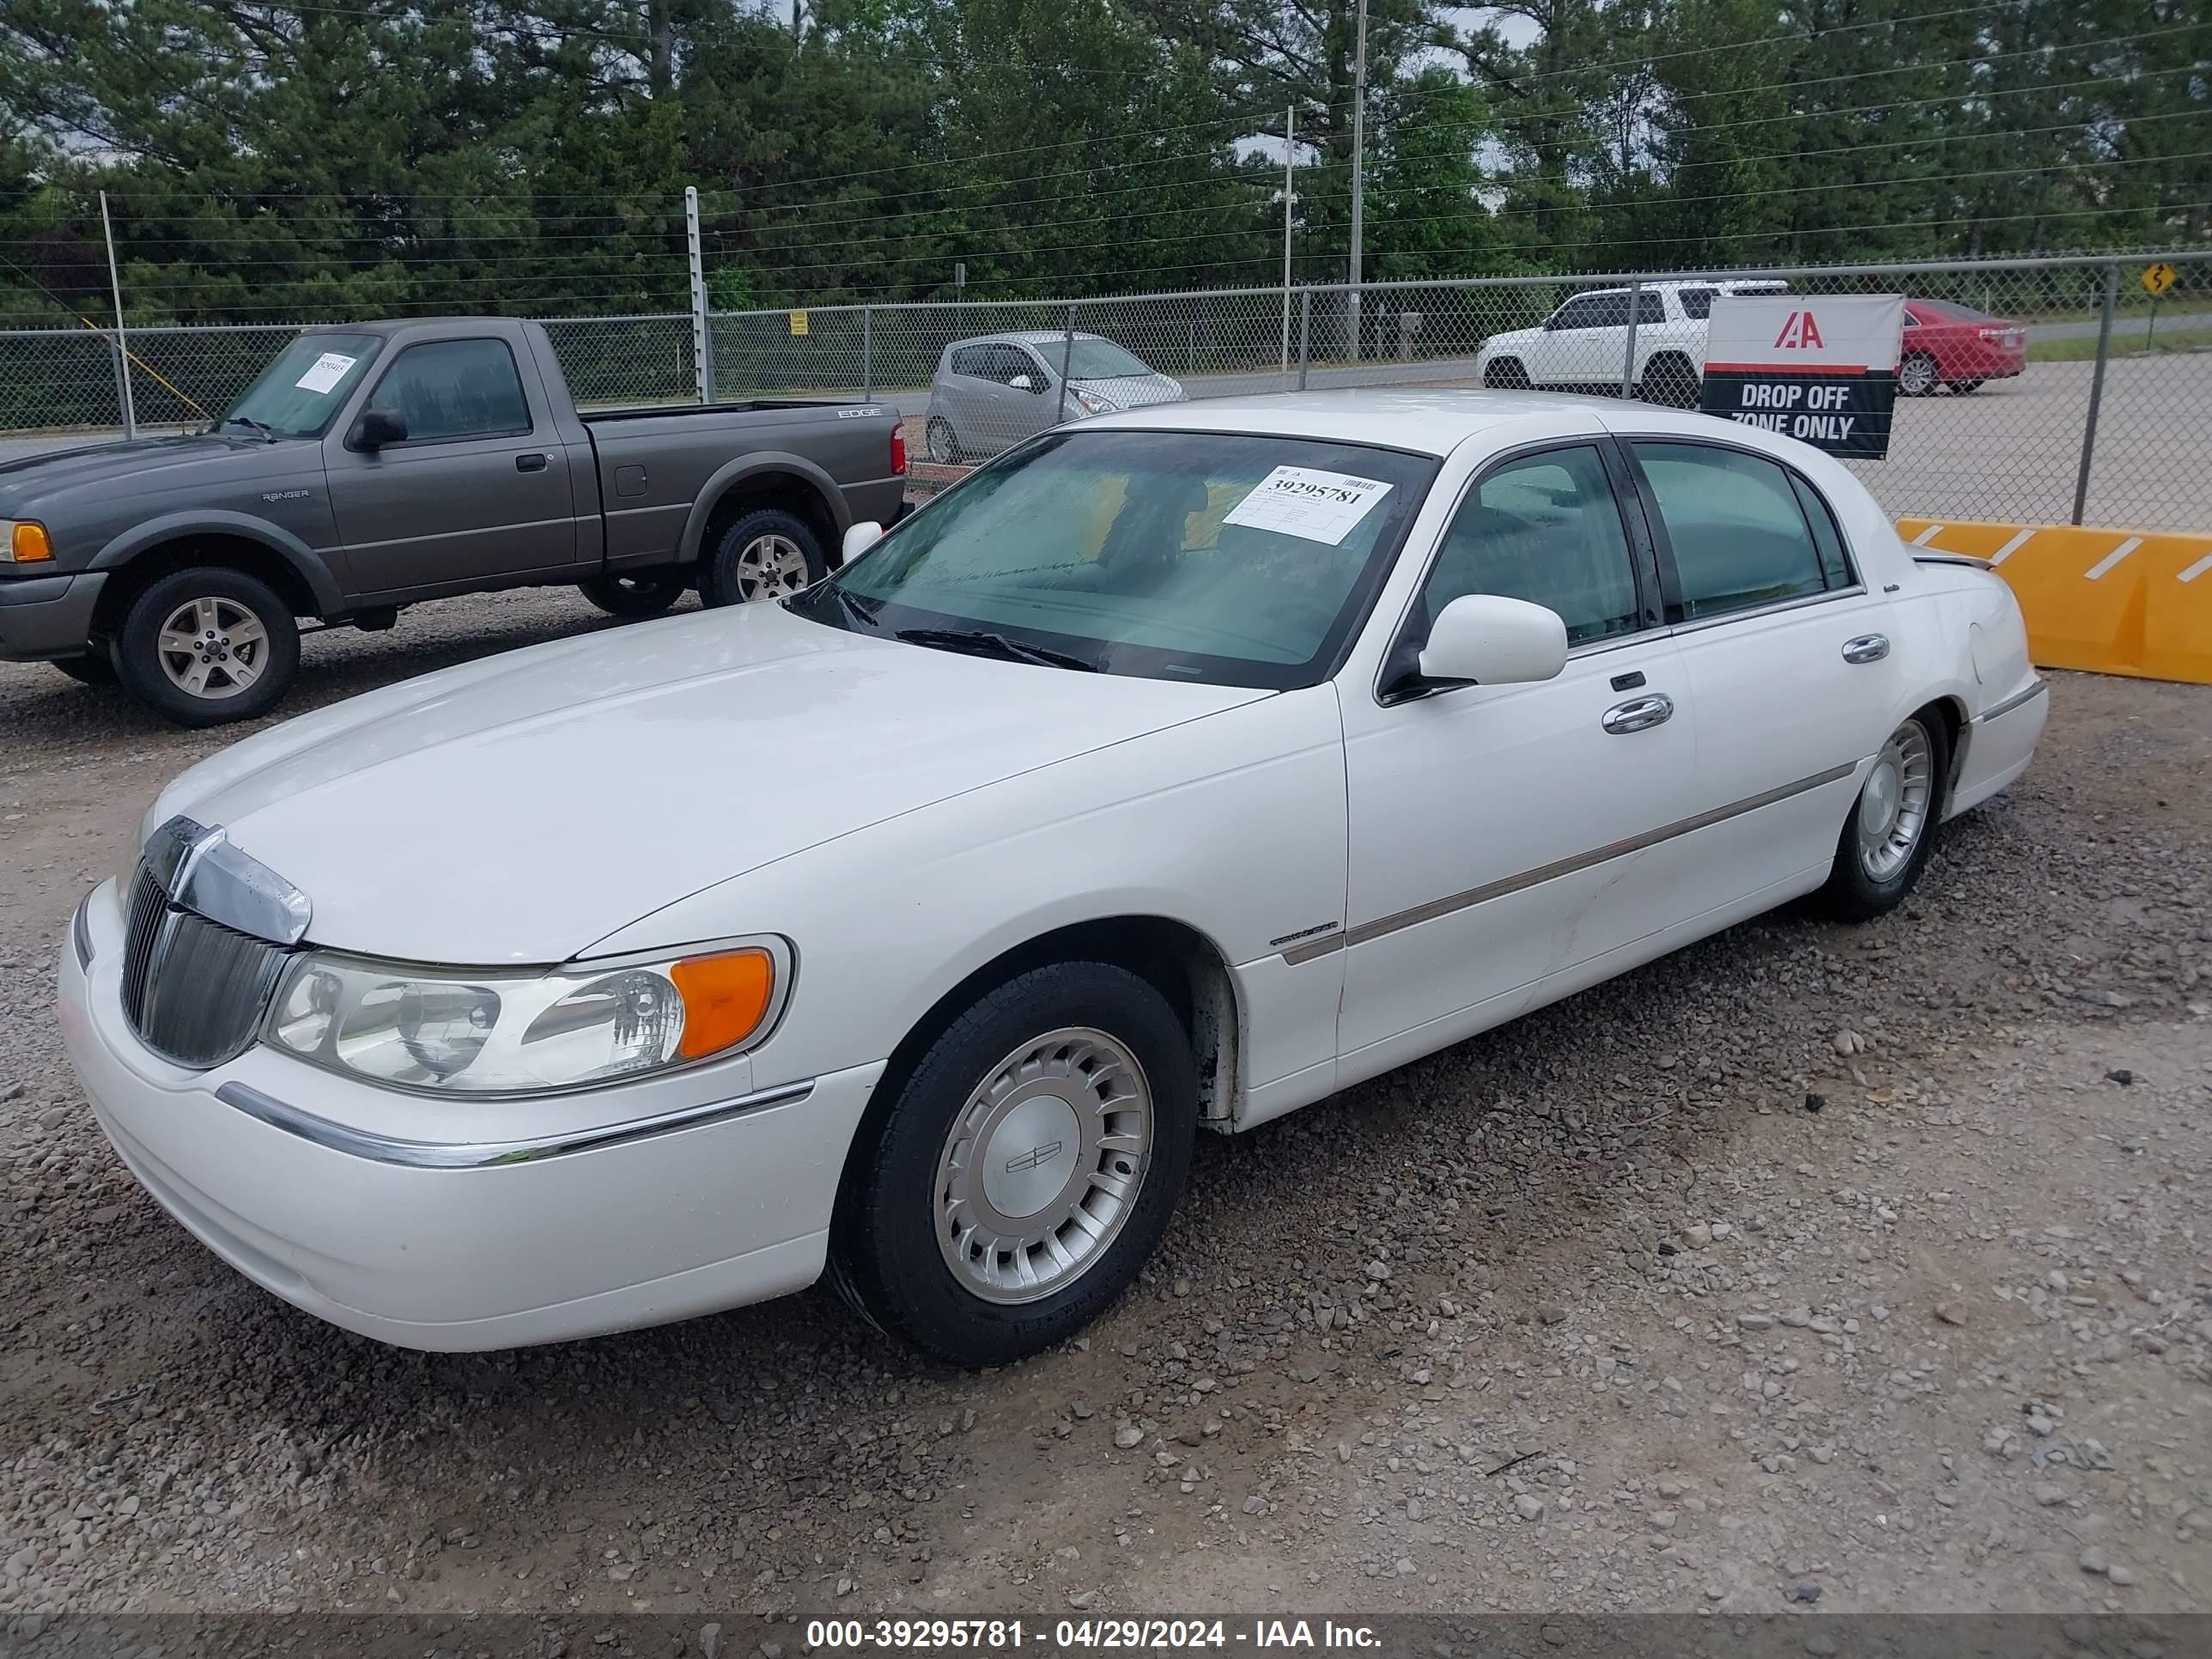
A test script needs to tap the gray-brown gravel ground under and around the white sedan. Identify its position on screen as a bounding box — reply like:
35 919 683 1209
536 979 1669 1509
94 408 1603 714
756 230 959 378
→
0 595 2212 1655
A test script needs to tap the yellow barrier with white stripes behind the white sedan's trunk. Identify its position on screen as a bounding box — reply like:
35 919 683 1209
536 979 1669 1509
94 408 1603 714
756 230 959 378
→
1898 518 2212 686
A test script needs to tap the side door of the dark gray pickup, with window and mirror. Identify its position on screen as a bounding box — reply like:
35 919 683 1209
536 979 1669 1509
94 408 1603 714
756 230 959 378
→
325 337 595 602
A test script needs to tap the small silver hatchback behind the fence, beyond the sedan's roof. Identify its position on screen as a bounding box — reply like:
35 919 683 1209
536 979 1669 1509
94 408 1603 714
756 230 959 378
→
929 330 1186 465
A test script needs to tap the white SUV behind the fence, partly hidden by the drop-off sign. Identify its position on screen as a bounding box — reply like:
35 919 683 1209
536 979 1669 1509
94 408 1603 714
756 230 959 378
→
1475 281 1790 410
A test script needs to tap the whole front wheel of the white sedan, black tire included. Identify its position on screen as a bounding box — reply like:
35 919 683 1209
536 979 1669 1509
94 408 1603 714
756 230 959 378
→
830 963 1199 1367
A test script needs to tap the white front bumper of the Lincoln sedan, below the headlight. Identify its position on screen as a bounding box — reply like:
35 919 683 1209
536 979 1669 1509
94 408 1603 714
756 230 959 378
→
58 883 883 1349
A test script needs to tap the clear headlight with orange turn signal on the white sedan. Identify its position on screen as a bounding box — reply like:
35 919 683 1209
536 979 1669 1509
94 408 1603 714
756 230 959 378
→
261 940 790 1095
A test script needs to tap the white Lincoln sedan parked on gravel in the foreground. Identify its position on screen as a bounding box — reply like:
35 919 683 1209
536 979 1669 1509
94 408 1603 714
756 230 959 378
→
60 392 2048 1364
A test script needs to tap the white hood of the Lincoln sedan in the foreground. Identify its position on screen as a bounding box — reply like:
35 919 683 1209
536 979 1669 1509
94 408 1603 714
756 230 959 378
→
143 604 1267 967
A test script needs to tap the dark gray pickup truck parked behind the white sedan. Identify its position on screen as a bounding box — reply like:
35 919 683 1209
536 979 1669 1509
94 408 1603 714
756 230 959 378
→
0 319 907 726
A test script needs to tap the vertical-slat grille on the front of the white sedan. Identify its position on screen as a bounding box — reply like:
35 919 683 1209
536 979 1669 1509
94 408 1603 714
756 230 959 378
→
124 865 289 1068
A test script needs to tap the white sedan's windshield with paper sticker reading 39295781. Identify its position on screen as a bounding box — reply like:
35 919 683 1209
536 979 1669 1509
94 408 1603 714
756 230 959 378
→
790 431 1437 688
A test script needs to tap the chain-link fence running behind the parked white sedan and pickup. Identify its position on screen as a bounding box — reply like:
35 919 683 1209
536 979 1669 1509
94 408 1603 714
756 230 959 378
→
0 252 2212 531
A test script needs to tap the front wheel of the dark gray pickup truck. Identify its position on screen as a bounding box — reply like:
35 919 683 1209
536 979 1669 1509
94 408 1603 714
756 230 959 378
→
115 564 299 726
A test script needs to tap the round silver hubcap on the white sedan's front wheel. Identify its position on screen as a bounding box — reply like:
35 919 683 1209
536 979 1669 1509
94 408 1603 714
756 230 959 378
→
936 1026 1152 1303
